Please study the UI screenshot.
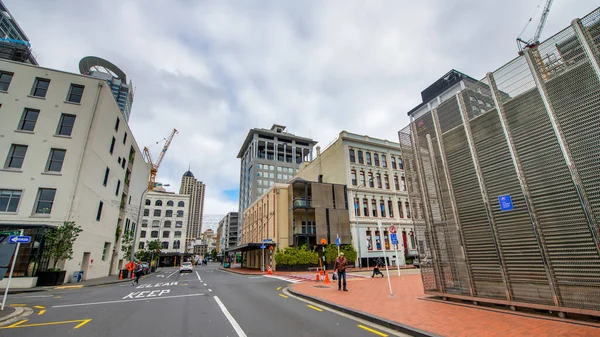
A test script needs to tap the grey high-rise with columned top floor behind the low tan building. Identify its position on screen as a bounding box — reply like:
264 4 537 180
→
237 124 317 243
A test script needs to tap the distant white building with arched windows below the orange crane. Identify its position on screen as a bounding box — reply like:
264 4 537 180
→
136 191 190 256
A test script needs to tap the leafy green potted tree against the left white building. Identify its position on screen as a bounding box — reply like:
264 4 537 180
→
43 221 83 271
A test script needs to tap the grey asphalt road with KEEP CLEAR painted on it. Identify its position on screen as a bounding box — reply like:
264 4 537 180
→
0 265 406 337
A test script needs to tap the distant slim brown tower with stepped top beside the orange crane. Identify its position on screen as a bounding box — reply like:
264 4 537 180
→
179 170 206 248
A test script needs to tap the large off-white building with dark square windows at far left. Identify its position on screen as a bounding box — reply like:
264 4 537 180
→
0 60 149 287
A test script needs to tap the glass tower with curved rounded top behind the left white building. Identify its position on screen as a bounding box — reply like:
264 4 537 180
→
79 56 134 122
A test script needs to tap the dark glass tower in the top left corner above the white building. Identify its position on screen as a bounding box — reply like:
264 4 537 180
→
0 0 38 65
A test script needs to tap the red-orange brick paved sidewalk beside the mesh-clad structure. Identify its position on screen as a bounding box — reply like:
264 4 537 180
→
291 273 600 336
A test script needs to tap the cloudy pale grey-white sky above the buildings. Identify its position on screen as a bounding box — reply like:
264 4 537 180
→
3 0 598 214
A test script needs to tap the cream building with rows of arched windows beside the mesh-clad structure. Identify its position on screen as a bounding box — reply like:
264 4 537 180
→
297 131 417 265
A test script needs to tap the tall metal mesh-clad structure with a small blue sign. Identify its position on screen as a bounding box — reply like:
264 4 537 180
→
399 8 600 316
